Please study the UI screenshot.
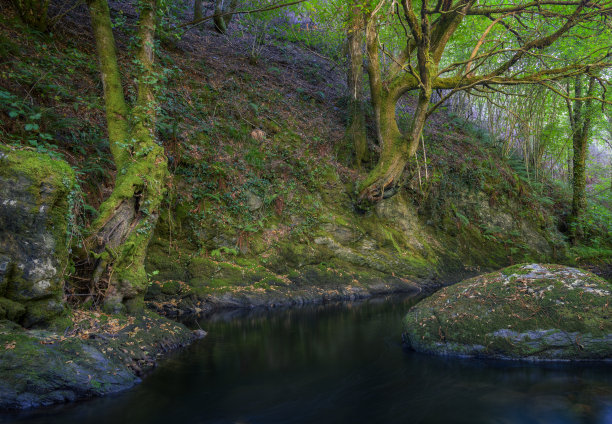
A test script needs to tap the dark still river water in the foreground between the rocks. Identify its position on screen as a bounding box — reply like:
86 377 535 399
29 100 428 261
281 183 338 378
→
0 298 612 424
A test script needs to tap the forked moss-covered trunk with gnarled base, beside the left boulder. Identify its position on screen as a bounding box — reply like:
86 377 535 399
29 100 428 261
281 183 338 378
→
87 0 168 312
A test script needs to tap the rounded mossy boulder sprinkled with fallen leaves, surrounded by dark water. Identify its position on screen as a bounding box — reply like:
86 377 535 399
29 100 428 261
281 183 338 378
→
404 264 612 361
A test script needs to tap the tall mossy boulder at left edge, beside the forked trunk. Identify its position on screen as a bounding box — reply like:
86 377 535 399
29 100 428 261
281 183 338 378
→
0 146 75 327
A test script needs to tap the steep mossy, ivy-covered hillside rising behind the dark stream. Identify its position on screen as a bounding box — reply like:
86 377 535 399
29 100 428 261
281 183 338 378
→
0 3 600 320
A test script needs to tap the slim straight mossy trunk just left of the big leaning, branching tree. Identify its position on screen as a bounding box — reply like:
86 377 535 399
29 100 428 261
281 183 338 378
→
345 4 368 169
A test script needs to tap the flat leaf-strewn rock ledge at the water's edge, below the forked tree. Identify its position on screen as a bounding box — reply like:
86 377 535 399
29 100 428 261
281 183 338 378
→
0 311 196 409
